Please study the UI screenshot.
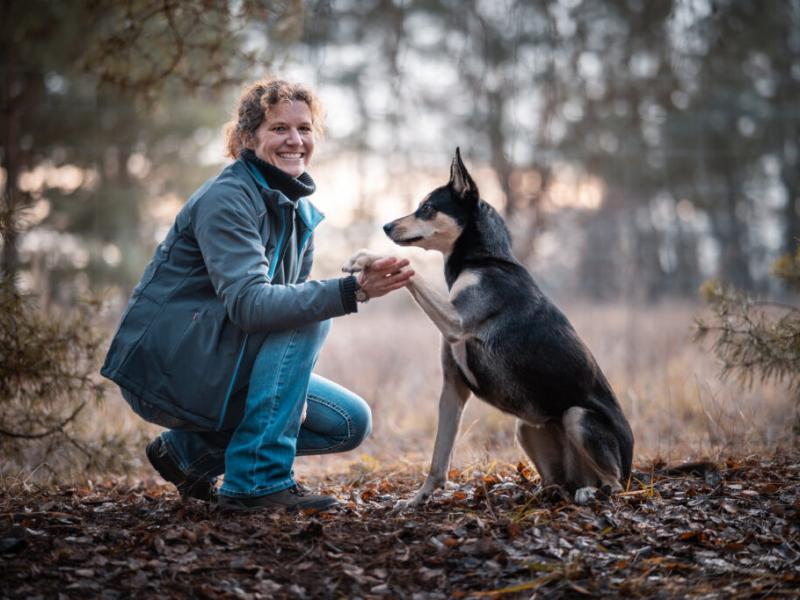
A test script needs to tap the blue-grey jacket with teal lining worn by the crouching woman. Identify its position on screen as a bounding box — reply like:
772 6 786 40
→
100 159 355 429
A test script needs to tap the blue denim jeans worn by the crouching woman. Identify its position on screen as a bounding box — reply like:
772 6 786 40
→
123 321 372 497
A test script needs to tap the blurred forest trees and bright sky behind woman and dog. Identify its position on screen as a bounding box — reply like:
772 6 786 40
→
0 0 800 478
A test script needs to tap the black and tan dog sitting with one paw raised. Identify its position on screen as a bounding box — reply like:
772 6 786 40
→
343 148 633 509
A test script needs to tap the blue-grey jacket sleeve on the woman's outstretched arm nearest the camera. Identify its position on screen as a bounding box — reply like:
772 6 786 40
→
192 189 352 332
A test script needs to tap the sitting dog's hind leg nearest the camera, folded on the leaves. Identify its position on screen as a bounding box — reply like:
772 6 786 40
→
562 406 622 504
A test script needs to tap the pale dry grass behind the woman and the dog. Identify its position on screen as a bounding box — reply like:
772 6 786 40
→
87 293 796 486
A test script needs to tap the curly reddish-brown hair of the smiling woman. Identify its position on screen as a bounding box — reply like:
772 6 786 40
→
224 77 324 158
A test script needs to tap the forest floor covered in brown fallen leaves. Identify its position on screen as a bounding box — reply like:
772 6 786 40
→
0 450 800 599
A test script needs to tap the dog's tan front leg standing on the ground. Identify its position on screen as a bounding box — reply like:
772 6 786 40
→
395 340 470 511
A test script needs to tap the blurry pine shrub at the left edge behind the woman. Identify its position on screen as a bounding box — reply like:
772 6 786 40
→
0 276 135 480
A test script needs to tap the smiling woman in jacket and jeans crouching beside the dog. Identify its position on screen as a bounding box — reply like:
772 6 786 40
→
101 79 413 510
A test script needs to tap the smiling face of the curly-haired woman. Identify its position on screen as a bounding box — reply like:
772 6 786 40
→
248 100 314 177
